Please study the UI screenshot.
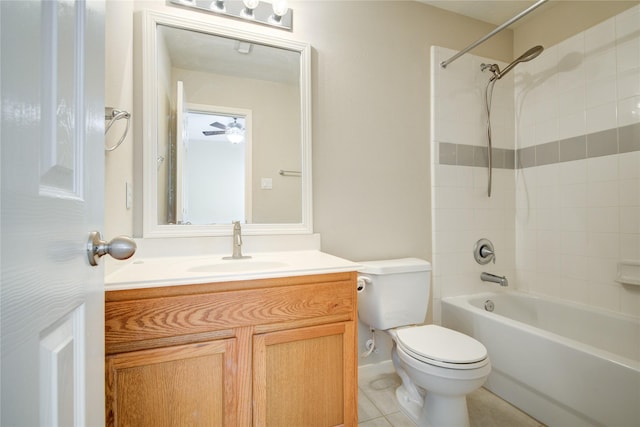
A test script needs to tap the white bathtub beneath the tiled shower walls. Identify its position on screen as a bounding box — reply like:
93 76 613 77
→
442 291 640 427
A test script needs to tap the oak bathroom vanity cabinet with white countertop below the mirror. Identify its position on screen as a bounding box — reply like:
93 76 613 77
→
105 251 357 427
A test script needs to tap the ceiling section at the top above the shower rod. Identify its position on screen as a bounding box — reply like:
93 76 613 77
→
417 0 551 28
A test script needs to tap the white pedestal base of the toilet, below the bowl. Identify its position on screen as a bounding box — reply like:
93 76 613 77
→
396 386 469 427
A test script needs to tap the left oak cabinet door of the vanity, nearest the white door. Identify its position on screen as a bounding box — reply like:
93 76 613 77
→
106 338 238 427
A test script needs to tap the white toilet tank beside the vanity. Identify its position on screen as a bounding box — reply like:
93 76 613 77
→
358 258 431 330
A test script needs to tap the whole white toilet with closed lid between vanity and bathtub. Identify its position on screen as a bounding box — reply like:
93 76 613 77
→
358 258 491 427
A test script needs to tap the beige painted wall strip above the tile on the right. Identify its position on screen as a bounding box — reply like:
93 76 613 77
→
513 0 640 56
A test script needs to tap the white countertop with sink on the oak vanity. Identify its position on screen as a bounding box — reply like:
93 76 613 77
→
105 250 359 291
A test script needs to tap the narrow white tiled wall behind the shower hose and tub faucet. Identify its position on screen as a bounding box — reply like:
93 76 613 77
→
431 47 515 322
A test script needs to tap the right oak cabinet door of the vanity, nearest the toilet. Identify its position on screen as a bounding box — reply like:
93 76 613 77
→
253 322 358 427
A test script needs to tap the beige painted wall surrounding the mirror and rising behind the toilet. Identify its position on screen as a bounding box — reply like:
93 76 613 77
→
105 0 513 260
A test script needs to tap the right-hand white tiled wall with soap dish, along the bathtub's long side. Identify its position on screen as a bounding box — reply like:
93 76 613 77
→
514 6 640 317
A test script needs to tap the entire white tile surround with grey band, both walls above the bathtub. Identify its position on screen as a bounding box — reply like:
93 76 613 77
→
432 6 640 320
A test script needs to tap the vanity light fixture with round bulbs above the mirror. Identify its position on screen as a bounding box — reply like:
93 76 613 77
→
168 0 293 31
